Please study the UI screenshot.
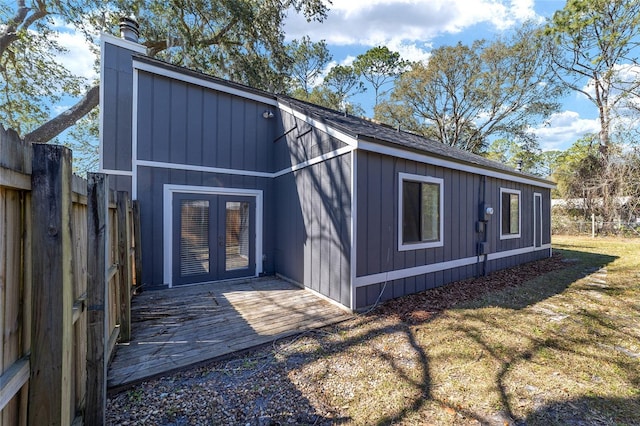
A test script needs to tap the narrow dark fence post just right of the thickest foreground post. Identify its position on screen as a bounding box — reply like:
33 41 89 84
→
85 173 110 425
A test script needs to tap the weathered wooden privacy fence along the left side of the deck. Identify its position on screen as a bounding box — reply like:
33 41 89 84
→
0 126 139 426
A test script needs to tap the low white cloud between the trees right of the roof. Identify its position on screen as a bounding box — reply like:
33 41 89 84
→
533 111 600 151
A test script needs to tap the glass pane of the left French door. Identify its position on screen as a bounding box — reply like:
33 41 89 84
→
180 200 210 277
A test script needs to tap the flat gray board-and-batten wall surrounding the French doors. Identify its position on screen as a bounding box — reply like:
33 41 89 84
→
135 58 276 287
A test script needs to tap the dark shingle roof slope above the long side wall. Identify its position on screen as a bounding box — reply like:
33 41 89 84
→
278 96 553 184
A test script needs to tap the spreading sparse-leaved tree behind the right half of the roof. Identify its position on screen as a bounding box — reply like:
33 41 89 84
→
378 24 562 153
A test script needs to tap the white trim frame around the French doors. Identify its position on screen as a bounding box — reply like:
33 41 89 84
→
162 184 263 288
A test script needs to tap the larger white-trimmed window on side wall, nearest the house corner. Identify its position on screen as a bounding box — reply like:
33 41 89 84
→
398 173 444 251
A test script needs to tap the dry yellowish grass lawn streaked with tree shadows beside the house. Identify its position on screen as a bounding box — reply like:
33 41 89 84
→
288 237 640 425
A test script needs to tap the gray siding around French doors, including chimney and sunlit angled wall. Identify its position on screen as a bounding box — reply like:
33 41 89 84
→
102 34 351 306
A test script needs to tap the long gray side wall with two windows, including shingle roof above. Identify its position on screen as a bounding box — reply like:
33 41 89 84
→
282 100 553 309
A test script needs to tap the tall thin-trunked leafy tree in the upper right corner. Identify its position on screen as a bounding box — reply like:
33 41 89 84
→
545 0 640 160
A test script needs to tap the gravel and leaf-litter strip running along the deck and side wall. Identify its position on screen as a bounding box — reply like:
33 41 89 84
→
107 256 564 426
